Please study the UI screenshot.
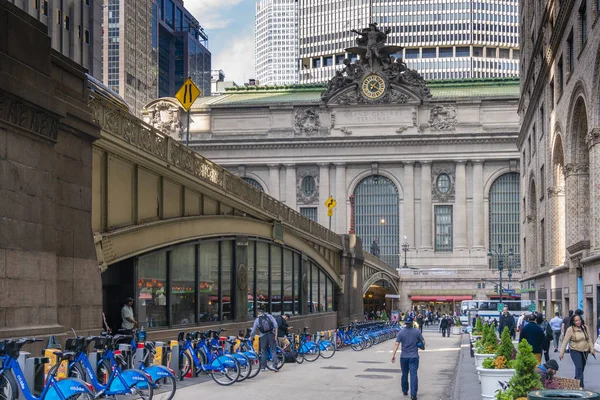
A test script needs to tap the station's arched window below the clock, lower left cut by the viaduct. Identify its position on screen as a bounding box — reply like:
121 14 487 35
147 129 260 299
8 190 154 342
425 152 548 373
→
354 175 400 267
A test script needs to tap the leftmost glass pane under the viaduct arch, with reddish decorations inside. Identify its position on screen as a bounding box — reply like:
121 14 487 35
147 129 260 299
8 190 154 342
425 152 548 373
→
136 251 169 328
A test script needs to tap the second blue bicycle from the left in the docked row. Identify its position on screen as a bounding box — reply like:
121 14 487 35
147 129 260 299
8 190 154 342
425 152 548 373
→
65 335 154 400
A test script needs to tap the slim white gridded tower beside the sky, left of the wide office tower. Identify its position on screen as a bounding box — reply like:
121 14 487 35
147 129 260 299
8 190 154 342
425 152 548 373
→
255 0 298 85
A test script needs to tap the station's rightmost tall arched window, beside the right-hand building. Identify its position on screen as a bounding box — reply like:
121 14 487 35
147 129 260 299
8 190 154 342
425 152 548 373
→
489 172 521 267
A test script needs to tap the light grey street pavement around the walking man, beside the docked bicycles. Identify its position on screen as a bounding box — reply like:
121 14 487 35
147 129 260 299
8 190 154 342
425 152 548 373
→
175 331 461 400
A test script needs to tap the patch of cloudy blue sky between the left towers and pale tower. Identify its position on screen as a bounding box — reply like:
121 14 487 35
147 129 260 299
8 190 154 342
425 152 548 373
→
183 0 256 84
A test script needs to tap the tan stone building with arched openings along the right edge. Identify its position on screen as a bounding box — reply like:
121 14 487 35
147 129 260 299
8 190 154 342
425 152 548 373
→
518 0 600 326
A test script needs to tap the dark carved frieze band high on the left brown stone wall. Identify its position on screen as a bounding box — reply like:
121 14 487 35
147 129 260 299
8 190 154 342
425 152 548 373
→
0 91 59 141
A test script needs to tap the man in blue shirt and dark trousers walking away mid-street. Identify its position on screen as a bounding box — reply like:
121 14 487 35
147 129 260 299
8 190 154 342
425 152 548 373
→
392 316 425 400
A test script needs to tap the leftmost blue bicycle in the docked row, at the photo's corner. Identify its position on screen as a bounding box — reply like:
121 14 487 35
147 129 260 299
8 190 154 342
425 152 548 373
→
0 338 94 400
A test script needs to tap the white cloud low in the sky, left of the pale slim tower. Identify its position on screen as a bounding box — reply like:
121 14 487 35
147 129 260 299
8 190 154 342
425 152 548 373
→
211 32 255 85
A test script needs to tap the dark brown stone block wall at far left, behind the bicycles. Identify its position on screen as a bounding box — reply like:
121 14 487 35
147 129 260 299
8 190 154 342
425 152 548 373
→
0 0 102 340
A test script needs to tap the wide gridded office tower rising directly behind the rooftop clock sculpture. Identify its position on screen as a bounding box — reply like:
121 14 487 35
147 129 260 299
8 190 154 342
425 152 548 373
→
299 0 520 83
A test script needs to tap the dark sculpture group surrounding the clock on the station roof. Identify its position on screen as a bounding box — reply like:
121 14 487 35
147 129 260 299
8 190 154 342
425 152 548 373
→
321 23 431 104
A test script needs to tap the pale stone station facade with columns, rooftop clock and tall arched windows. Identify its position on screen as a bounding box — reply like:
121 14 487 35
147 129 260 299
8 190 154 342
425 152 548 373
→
146 27 520 311
